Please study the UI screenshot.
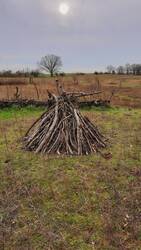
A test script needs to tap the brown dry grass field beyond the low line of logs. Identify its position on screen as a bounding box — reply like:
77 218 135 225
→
0 74 141 108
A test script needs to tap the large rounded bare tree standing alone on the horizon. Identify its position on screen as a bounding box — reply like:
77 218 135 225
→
39 55 62 77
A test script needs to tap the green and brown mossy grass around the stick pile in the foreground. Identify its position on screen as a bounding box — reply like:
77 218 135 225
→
0 107 141 250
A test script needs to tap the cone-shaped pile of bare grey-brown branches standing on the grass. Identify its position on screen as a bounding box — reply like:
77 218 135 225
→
24 91 106 155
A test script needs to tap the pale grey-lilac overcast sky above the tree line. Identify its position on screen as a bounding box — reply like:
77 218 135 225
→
0 0 141 72
